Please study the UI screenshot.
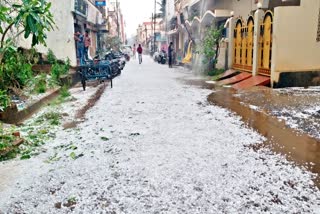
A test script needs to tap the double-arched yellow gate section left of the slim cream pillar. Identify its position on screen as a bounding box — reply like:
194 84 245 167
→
233 16 254 72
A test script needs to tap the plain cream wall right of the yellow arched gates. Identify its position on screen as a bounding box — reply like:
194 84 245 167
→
271 0 320 82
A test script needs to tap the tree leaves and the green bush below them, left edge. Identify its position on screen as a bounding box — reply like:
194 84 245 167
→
0 0 54 109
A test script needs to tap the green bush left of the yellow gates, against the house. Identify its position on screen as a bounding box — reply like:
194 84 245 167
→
198 26 223 69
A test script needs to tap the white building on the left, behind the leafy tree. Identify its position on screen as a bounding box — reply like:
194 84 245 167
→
10 0 108 66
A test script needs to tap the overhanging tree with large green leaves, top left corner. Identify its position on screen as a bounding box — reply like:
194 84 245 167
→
0 0 54 63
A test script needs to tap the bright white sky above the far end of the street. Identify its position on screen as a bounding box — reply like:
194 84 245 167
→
119 0 159 38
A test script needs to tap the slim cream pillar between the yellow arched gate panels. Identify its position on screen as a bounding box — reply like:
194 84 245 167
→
252 3 264 76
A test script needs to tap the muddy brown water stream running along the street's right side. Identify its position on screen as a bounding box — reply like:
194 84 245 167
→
182 80 320 188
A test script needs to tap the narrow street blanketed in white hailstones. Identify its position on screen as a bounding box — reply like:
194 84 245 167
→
0 56 320 214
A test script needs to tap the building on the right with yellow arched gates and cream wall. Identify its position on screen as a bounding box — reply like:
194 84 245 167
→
168 0 320 87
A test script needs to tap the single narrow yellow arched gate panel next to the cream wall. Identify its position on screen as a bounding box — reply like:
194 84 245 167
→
259 12 272 75
